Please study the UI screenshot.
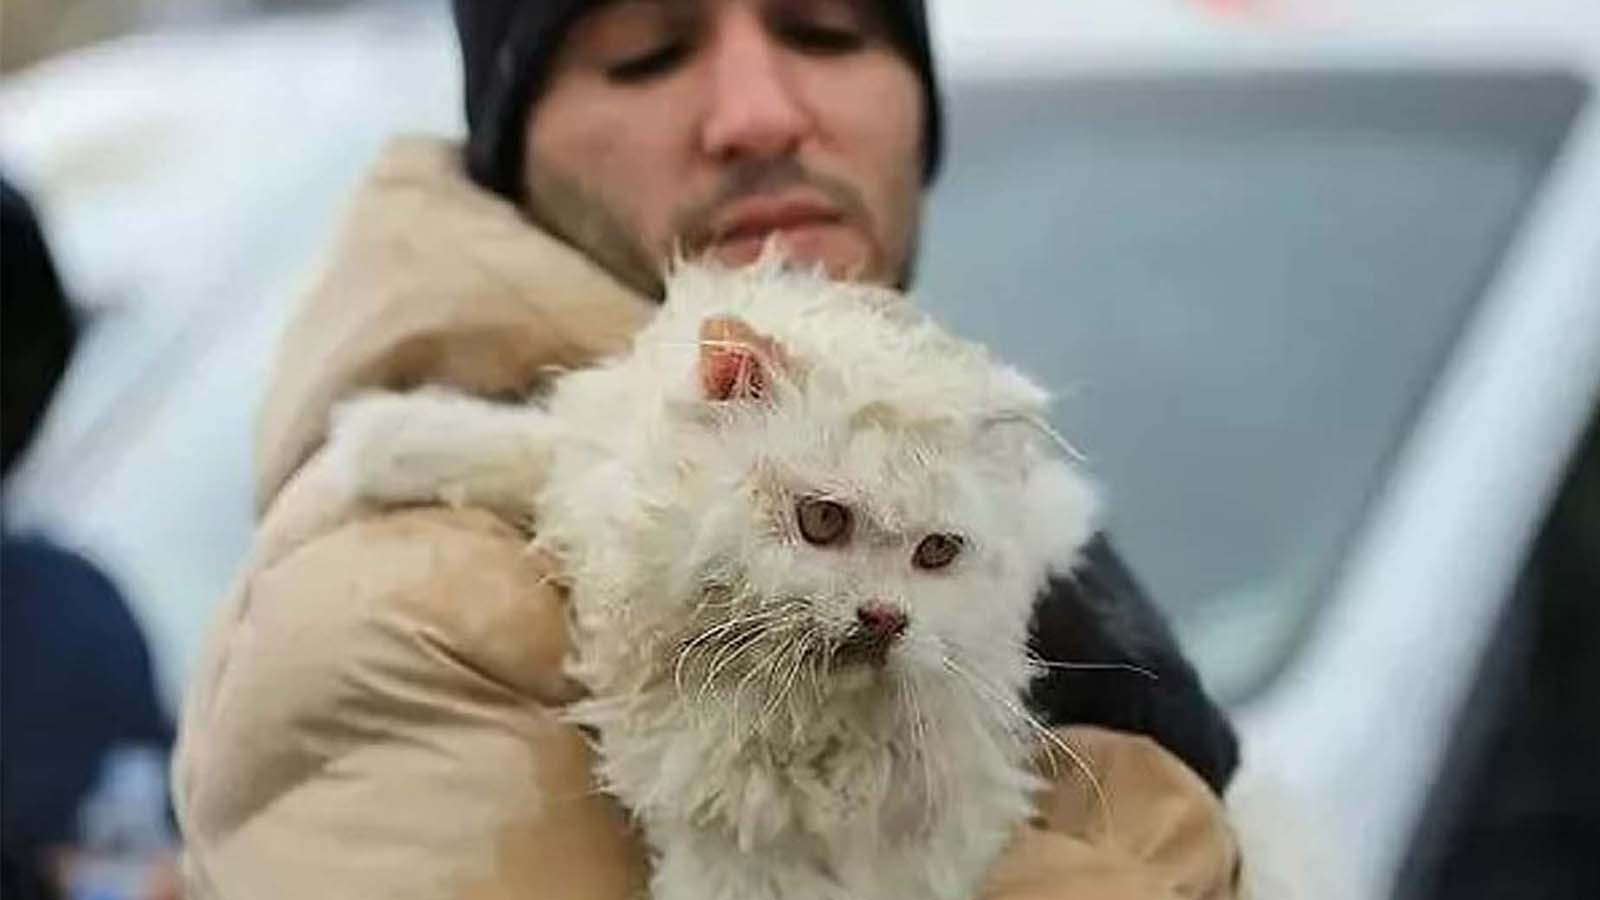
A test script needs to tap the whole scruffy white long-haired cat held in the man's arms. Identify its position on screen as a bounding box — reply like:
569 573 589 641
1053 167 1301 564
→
333 259 1094 900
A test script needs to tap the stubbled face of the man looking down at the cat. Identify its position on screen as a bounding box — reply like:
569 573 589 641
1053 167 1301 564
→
525 0 923 295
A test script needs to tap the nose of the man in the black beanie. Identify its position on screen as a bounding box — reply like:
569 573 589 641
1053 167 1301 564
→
701 3 811 162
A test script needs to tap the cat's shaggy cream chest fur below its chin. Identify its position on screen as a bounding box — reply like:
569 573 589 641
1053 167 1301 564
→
574 650 1035 900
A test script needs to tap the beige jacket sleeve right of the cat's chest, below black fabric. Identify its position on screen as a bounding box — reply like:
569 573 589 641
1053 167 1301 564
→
984 725 1242 900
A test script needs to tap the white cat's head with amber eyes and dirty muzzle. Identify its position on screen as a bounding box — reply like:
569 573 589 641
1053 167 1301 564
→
614 267 1094 723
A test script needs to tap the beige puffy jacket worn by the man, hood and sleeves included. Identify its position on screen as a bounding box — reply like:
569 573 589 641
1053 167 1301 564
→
174 139 1238 900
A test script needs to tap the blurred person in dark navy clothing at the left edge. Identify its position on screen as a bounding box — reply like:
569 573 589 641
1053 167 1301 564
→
0 181 178 900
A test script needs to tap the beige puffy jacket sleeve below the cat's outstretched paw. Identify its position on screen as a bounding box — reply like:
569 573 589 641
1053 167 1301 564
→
176 496 643 900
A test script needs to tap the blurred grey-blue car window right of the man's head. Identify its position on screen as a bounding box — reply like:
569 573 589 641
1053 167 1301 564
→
918 72 1584 700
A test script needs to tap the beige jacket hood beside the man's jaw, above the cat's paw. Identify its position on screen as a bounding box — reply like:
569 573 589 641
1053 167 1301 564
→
256 138 654 509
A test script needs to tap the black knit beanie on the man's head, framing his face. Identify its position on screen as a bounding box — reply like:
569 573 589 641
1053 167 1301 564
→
451 0 942 199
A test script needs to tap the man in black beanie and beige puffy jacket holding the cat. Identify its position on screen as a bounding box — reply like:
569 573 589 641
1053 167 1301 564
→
178 0 1238 900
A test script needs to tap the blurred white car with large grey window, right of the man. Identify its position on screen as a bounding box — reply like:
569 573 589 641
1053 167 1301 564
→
922 36 1600 898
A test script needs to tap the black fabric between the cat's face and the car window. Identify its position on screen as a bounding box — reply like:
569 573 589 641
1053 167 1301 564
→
1027 536 1238 793
